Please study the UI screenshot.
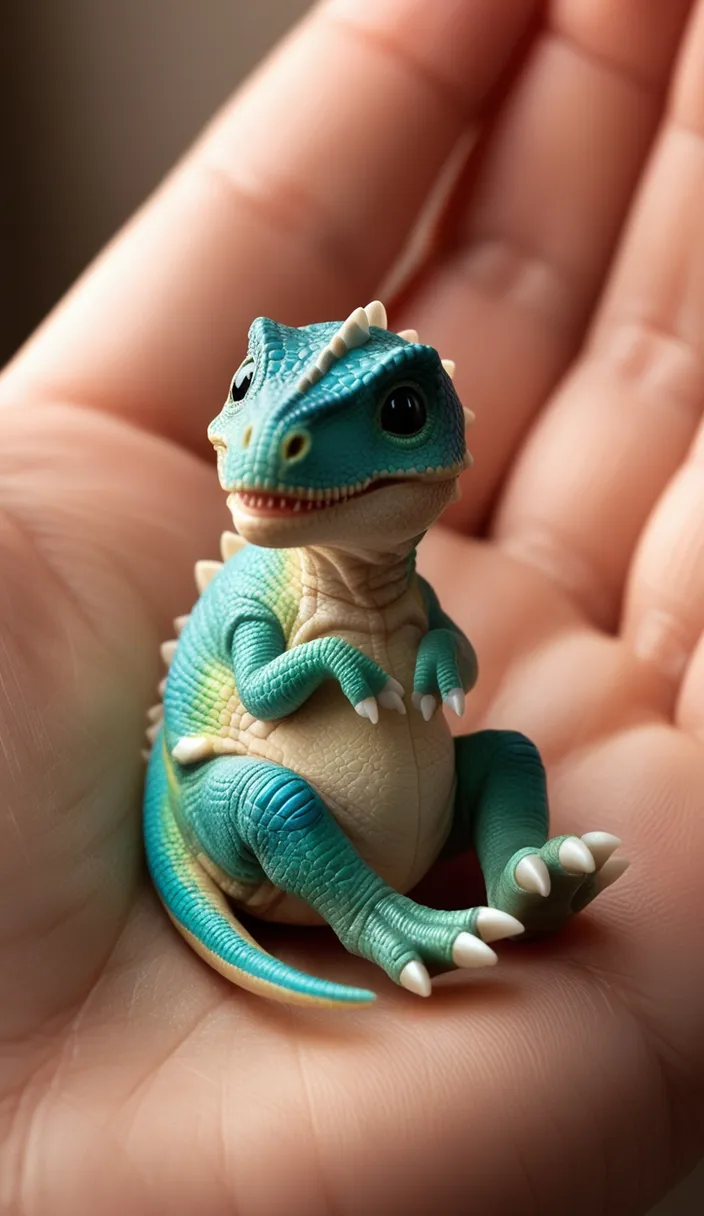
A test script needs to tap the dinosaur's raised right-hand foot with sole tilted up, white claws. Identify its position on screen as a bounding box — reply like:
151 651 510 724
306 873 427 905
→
490 832 629 934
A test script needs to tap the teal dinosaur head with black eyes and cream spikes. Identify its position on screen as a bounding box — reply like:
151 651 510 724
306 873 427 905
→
208 302 469 548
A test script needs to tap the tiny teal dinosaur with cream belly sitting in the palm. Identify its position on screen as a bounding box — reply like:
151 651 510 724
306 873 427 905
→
145 300 624 1006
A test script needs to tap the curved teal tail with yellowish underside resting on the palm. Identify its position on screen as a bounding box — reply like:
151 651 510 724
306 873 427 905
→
145 732 374 1008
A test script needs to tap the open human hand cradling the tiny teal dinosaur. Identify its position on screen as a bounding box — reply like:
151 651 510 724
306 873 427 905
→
0 0 704 1216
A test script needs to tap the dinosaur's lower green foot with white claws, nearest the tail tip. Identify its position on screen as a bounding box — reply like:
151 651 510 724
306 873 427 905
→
343 893 523 996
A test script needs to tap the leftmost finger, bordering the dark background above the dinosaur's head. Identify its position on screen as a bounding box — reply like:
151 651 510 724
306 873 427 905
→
2 0 534 452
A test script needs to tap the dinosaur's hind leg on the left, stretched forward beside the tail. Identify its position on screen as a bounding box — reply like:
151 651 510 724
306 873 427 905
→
182 756 519 996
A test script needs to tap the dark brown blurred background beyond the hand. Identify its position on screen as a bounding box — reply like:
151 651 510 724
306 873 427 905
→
0 0 704 1216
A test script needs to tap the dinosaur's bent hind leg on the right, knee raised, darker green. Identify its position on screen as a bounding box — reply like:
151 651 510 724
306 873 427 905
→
447 731 625 933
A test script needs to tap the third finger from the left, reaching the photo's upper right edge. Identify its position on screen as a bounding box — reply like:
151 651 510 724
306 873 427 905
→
495 2 704 627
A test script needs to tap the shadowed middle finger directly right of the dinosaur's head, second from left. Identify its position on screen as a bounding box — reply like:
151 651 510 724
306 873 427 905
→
391 0 689 528
